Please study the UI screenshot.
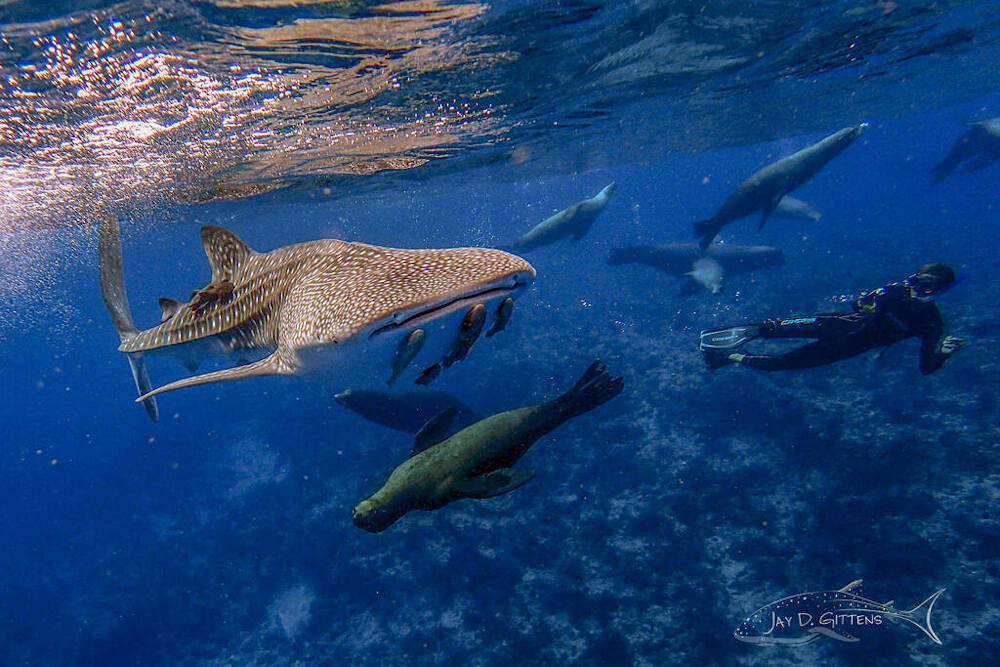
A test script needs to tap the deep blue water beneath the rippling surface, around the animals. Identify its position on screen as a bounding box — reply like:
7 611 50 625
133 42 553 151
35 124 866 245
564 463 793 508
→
0 1 1000 665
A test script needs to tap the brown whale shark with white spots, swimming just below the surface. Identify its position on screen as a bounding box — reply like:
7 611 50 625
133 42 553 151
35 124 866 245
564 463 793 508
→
100 216 535 412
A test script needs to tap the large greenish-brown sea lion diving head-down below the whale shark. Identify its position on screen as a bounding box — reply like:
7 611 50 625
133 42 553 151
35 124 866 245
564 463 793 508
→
353 361 624 533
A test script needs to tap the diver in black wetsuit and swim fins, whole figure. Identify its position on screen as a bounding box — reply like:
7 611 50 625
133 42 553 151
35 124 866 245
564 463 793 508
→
699 264 963 375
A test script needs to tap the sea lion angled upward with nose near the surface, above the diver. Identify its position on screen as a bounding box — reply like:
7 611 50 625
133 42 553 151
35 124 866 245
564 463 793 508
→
694 123 868 248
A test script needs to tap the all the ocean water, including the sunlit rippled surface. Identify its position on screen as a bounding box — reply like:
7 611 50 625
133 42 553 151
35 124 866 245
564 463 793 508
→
0 0 1000 666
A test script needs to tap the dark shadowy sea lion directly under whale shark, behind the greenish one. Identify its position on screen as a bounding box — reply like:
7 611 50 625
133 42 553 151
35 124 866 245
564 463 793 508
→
334 388 479 433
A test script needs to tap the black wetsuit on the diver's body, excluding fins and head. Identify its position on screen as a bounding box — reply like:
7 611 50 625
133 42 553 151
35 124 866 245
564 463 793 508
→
740 283 949 375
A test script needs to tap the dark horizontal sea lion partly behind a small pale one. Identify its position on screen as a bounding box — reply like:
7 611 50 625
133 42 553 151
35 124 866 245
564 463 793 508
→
608 243 785 290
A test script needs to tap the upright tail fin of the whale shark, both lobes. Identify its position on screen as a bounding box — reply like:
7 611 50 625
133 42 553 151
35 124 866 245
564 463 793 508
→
97 211 160 422
